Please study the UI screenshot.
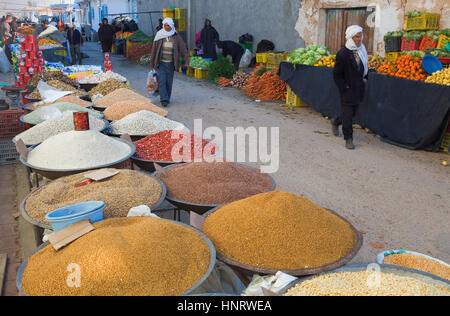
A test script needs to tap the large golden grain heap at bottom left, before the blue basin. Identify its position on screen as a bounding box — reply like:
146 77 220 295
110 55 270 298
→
22 218 210 296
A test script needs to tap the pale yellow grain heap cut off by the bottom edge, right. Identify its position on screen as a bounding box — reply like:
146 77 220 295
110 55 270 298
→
285 271 450 296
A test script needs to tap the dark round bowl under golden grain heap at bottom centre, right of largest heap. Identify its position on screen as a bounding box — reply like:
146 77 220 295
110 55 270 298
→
204 206 363 276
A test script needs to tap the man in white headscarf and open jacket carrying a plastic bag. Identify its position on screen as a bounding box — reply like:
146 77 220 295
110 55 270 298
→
147 18 189 107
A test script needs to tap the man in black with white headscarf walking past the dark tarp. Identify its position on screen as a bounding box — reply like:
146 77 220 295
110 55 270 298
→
331 25 369 149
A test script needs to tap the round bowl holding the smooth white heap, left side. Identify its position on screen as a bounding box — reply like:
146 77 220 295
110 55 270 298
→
20 138 136 180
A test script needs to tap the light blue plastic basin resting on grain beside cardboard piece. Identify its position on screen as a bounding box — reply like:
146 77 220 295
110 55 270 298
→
45 201 105 232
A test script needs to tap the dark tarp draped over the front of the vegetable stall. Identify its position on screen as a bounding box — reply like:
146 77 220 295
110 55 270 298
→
279 62 450 151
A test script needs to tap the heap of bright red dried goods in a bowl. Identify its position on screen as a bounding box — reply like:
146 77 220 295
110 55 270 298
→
134 130 217 162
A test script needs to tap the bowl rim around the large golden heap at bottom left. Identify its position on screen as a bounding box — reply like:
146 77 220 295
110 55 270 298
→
16 219 216 296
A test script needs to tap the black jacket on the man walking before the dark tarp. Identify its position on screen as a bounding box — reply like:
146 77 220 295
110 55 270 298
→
334 47 365 105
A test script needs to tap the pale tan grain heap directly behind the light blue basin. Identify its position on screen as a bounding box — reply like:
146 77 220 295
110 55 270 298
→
25 169 163 225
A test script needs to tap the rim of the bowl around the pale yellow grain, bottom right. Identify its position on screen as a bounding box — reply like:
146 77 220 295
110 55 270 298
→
281 263 450 294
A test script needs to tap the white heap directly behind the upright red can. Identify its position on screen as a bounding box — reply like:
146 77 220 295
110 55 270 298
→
13 111 107 145
